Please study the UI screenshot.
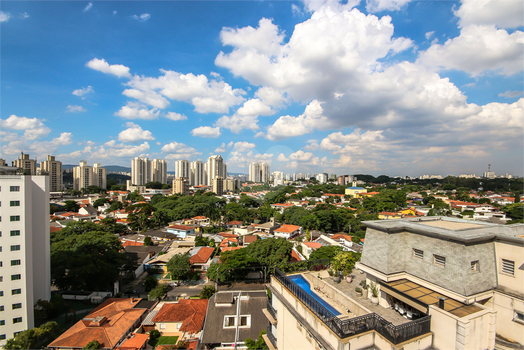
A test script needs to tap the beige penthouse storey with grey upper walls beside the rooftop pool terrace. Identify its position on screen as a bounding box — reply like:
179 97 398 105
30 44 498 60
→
356 217 524 349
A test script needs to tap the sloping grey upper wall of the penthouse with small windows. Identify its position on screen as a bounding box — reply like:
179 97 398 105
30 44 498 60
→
361 228 497 296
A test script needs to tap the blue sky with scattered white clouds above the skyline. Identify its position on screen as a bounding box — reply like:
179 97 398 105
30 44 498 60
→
0 0 524 176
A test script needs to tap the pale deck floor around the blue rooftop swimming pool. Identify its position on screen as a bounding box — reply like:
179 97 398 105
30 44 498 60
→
304 269 411 326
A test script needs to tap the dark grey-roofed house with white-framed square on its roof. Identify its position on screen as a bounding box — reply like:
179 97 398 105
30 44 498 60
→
201 289 269 350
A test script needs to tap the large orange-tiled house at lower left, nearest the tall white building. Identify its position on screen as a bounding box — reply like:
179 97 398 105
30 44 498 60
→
48 298 156 349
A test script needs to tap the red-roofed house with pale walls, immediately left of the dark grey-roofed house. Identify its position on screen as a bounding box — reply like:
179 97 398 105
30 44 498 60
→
152 299 208 341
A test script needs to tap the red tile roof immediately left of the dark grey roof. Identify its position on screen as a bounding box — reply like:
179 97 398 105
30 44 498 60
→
153 299 209 333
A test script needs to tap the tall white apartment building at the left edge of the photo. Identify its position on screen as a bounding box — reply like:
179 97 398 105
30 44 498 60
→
0 174 51 345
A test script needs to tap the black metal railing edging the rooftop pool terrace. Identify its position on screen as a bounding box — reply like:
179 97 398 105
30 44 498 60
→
273 268 431 344
